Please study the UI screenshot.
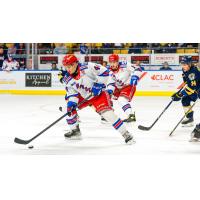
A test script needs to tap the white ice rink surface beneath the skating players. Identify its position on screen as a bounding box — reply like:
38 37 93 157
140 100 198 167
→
0 95 200 155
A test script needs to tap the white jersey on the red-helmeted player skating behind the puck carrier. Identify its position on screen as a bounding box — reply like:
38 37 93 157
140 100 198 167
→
107 61 142 91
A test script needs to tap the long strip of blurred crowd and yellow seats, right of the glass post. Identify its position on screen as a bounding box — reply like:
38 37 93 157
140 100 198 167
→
34 43 198 54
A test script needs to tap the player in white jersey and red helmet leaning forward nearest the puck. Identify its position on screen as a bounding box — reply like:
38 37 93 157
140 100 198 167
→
63 55 135 144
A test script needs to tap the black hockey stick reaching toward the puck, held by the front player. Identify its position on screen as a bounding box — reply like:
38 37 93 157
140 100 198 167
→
14 94 93 145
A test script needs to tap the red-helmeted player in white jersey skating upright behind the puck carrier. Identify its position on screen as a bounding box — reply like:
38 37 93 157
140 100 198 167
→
107 54 142 123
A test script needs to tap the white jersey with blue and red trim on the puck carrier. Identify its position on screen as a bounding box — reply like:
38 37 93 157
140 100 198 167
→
63 62 109 103
